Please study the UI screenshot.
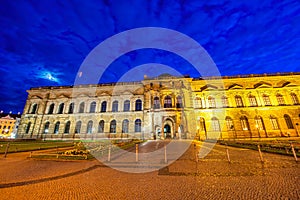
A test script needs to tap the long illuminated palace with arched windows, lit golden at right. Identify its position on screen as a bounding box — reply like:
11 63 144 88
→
18 73 300 140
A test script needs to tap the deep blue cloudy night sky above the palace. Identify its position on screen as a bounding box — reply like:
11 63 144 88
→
0 0 300 113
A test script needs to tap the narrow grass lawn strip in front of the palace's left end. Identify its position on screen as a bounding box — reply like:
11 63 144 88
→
0 141 74 154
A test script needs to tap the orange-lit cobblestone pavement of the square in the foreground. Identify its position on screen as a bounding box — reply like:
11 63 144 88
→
0 141 300 199
